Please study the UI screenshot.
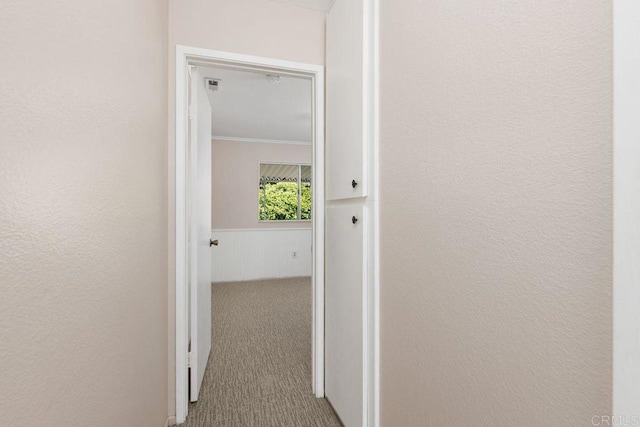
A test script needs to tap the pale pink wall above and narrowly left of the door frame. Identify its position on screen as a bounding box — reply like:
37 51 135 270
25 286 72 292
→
168 0 325 412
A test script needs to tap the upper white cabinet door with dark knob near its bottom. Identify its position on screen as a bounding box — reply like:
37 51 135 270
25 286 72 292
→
326 0 372 200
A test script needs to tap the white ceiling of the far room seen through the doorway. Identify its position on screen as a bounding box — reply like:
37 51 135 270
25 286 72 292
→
200 67 312 144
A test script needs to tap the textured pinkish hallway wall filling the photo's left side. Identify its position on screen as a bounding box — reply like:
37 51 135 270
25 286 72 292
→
0 0 168 427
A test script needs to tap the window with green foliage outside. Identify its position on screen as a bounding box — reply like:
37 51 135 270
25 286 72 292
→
258 163 311 221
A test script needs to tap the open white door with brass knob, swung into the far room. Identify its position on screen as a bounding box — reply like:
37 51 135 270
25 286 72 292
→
189 68 211 402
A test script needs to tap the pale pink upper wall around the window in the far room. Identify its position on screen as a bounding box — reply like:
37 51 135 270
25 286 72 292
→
211 141 311 229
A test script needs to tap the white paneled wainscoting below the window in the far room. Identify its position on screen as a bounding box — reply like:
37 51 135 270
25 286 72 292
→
211 228 312 282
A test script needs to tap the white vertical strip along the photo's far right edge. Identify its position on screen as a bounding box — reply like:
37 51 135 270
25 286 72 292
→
613 0 640 420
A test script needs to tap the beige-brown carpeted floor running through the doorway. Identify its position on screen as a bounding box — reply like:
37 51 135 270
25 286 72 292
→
185 278 341 427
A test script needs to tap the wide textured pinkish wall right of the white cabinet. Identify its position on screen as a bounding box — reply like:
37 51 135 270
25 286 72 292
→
380 0 612 427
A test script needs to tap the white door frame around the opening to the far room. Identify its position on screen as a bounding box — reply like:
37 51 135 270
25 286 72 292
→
175 45 325 423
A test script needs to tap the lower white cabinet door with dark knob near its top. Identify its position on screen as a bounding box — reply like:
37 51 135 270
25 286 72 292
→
325 205 367 427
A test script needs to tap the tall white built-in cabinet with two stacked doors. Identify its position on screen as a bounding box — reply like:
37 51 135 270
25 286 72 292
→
325 0 373 427
